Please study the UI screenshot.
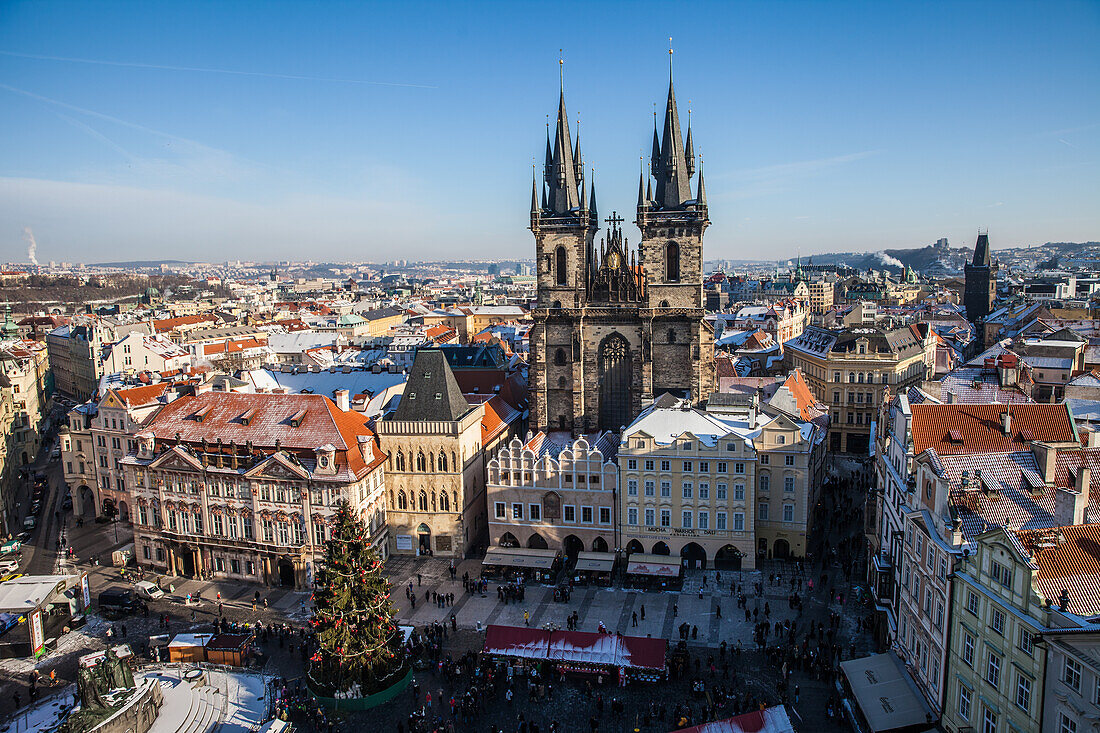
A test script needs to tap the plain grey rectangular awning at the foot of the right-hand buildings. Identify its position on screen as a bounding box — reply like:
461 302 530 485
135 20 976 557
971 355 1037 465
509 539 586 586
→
840 654 935 733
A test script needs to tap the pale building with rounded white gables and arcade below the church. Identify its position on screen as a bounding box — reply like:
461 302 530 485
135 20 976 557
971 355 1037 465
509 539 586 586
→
487 433 619 558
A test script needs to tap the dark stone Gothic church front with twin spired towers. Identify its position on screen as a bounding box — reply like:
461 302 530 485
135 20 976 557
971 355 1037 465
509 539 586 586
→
530 67 714 436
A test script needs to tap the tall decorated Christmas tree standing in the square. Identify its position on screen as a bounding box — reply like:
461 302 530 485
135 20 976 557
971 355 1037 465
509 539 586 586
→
309 504 407 697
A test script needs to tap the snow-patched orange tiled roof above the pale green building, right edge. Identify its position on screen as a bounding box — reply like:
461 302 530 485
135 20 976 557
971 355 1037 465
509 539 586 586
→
1016 524 1100 616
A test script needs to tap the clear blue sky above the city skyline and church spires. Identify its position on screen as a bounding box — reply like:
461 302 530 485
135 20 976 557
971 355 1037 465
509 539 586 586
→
0 1 1100 262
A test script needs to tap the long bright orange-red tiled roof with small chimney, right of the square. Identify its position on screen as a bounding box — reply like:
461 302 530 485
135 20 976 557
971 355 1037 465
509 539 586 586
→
912 403 1078 456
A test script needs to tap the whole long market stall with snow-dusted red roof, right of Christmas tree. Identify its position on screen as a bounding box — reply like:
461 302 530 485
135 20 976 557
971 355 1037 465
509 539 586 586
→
482 625 668 682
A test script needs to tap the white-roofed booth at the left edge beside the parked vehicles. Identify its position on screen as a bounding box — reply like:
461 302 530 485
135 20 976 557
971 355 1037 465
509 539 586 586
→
0 573 90 658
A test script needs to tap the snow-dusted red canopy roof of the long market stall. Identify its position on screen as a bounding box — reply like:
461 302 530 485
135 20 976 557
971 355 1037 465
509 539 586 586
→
482 624 668 669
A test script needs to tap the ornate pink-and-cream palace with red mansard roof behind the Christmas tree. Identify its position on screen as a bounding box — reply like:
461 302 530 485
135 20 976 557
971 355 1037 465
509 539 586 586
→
121 387 386 588
